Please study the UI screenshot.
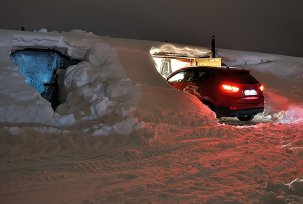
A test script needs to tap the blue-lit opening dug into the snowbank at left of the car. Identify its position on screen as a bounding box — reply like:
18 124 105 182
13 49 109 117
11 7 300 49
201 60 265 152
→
10 49 80 110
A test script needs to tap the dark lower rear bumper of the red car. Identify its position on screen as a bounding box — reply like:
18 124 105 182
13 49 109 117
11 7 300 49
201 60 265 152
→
214 106 264 117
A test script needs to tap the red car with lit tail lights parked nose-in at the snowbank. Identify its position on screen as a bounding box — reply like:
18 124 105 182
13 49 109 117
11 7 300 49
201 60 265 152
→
167 67 264 121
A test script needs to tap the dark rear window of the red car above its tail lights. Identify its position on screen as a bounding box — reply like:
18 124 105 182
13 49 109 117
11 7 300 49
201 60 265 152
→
222 72 258 84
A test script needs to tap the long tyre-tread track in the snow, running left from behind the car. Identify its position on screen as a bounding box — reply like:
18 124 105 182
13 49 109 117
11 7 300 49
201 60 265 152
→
0 125 258 188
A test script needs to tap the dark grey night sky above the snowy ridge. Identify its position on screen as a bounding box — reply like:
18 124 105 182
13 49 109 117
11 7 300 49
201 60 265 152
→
0 0 303 57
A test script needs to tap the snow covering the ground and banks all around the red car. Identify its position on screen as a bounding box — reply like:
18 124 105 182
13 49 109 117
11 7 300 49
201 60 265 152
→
0 30 303 203
